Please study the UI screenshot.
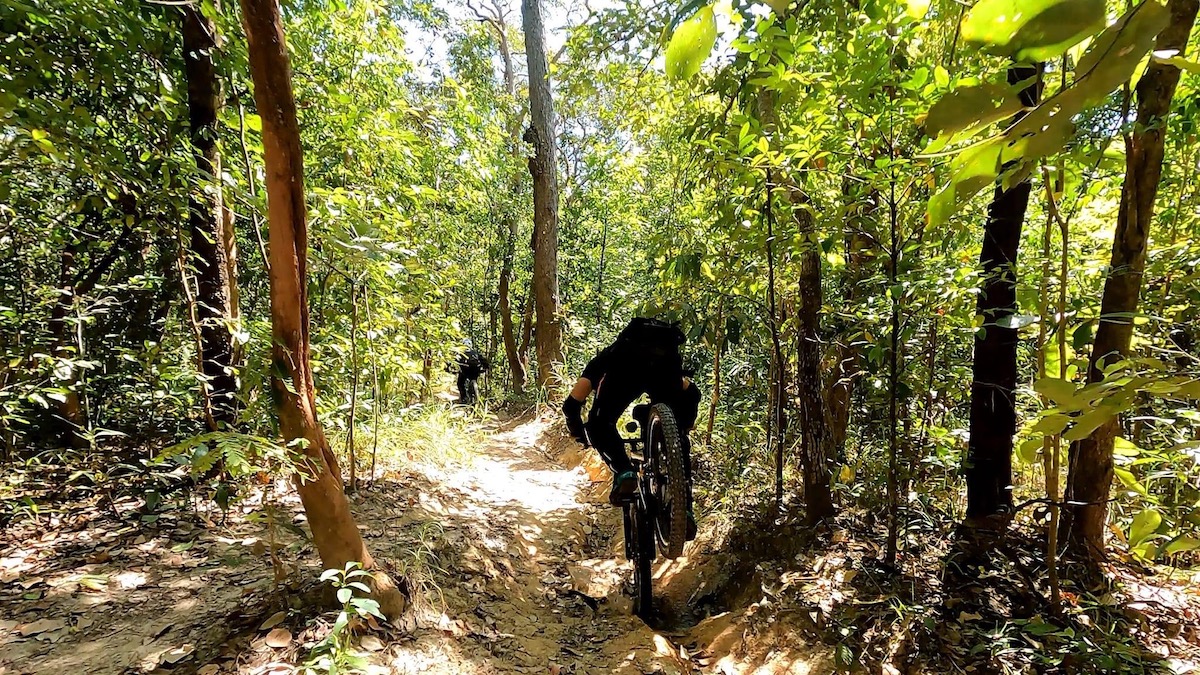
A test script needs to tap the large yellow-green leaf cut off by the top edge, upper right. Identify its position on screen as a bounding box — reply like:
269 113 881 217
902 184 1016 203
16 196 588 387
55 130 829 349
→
962 0 1105 61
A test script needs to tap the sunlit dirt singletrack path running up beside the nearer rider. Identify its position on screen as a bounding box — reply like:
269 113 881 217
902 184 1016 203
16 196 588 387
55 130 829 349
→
364 417 692 674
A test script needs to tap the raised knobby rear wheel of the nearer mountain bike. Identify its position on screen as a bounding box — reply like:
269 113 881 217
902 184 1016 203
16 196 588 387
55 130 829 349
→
650 404 688 560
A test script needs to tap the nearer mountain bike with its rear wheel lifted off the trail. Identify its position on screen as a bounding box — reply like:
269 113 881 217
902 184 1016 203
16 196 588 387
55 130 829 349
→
623 404 689 619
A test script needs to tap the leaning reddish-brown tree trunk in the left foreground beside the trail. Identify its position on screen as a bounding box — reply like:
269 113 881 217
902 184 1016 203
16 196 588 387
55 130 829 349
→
241 0 404 616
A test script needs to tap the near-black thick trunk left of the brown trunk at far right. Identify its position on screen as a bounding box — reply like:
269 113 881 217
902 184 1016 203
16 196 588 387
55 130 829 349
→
965 66 1040 530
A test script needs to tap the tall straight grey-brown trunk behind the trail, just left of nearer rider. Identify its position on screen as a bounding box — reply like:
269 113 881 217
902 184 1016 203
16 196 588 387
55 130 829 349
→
521 0 563 388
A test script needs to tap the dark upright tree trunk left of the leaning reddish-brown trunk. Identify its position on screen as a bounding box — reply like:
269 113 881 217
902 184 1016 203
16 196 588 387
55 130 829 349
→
182 5 238 431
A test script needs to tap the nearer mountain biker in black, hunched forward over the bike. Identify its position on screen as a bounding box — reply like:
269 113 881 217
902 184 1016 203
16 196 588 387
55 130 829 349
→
563 318 700 538
